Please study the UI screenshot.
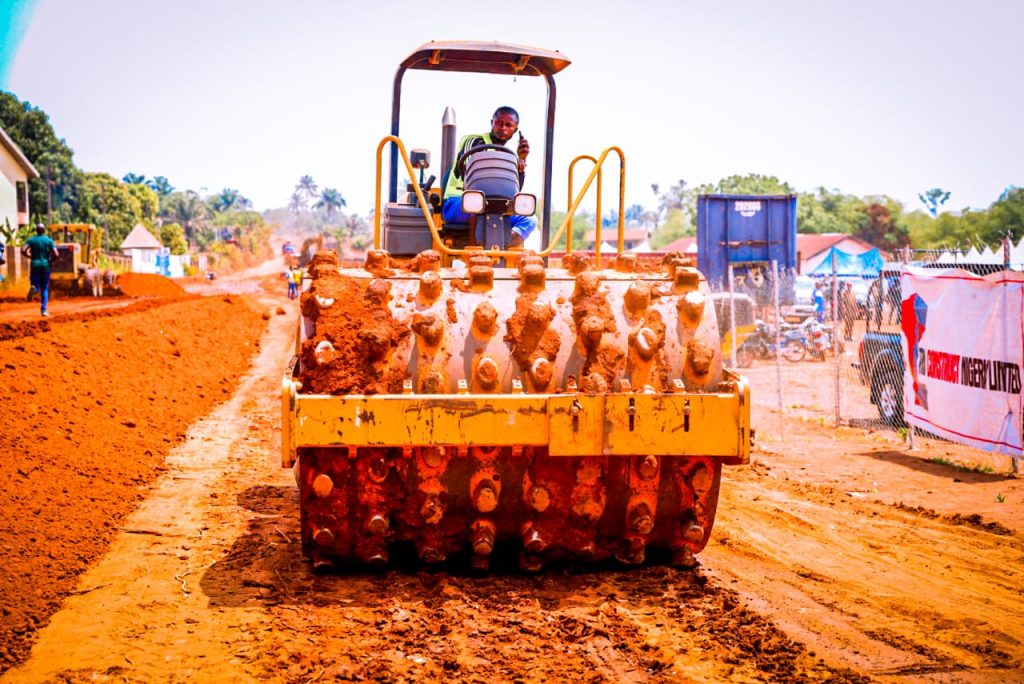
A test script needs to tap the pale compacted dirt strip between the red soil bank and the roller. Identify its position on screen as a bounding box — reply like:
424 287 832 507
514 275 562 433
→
2 302 294 682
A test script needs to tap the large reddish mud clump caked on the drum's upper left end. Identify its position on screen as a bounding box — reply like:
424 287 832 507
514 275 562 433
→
300 264 409 394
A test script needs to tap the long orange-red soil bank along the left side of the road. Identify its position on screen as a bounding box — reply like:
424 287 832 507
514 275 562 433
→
0 294 266 673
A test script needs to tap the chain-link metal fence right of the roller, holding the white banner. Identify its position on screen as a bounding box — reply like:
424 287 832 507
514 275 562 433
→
712 250 1019 472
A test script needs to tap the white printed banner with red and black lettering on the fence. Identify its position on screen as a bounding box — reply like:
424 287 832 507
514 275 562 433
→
900 267 1024 457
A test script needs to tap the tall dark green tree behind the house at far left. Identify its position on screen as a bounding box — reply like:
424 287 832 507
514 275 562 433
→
0 91 82 222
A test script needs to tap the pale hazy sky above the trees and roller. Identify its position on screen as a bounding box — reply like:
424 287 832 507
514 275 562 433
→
0 0 1024 215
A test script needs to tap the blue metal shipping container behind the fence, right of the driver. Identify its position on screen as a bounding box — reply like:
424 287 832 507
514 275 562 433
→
697 195 797 303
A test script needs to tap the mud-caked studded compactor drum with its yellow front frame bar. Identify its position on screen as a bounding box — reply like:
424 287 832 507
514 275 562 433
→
284 250 750 569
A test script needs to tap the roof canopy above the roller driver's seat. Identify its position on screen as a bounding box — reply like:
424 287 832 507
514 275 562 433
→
401 41 571 76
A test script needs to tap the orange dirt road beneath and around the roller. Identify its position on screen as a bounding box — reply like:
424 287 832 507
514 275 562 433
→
2 264 1024 682
